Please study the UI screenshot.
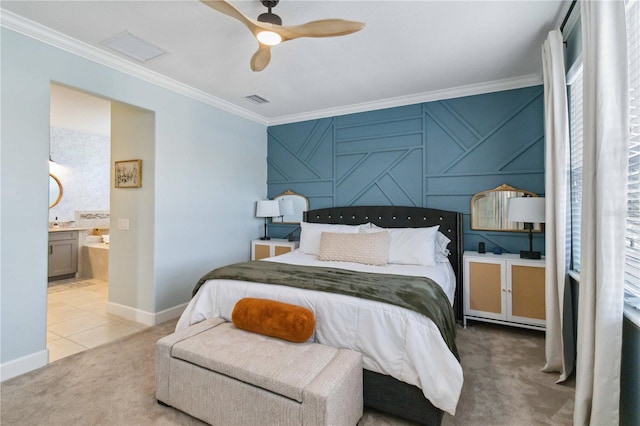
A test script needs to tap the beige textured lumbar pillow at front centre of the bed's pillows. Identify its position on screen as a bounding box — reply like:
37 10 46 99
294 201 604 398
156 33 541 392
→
318 231 389 265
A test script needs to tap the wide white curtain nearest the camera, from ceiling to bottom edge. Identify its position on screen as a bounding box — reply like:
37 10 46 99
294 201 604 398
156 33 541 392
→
573 0 629 425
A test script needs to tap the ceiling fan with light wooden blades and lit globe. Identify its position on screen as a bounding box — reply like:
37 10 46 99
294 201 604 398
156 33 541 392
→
200 0 365 71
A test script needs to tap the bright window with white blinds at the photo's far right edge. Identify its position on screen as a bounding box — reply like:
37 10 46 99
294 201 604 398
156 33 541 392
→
625 0 640 310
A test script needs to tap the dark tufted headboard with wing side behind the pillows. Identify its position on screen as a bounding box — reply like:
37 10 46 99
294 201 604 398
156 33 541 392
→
304 206 463 320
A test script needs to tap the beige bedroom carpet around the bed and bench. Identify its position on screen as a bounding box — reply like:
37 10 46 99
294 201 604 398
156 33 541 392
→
0 321 574 426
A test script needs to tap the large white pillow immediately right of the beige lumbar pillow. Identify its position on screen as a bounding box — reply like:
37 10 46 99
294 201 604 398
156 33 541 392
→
387 226 440 266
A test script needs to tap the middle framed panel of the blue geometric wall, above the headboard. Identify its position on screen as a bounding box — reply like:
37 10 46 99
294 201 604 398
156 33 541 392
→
335 105 424 206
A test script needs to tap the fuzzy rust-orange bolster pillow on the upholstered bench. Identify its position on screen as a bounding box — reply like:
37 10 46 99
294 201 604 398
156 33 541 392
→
231 297 316 343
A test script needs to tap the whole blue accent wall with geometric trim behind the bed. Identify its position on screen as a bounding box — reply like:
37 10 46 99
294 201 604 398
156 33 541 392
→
267 86 544 252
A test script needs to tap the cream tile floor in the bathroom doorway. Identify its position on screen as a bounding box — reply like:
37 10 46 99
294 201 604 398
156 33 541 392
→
47 279 147 362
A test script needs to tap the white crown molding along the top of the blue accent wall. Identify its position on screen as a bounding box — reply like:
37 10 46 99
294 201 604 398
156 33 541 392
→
269 74 542 126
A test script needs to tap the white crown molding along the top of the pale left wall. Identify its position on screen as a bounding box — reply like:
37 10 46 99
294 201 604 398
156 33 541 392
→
0 8 269 125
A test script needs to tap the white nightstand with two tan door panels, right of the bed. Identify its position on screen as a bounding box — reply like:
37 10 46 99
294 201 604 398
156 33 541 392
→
463 251 546 330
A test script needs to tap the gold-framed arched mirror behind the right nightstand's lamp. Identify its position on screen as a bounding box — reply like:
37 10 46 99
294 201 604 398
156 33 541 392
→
470 184 542 232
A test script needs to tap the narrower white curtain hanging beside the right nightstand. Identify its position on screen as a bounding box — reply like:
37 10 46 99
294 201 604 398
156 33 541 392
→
542 30 575 382
